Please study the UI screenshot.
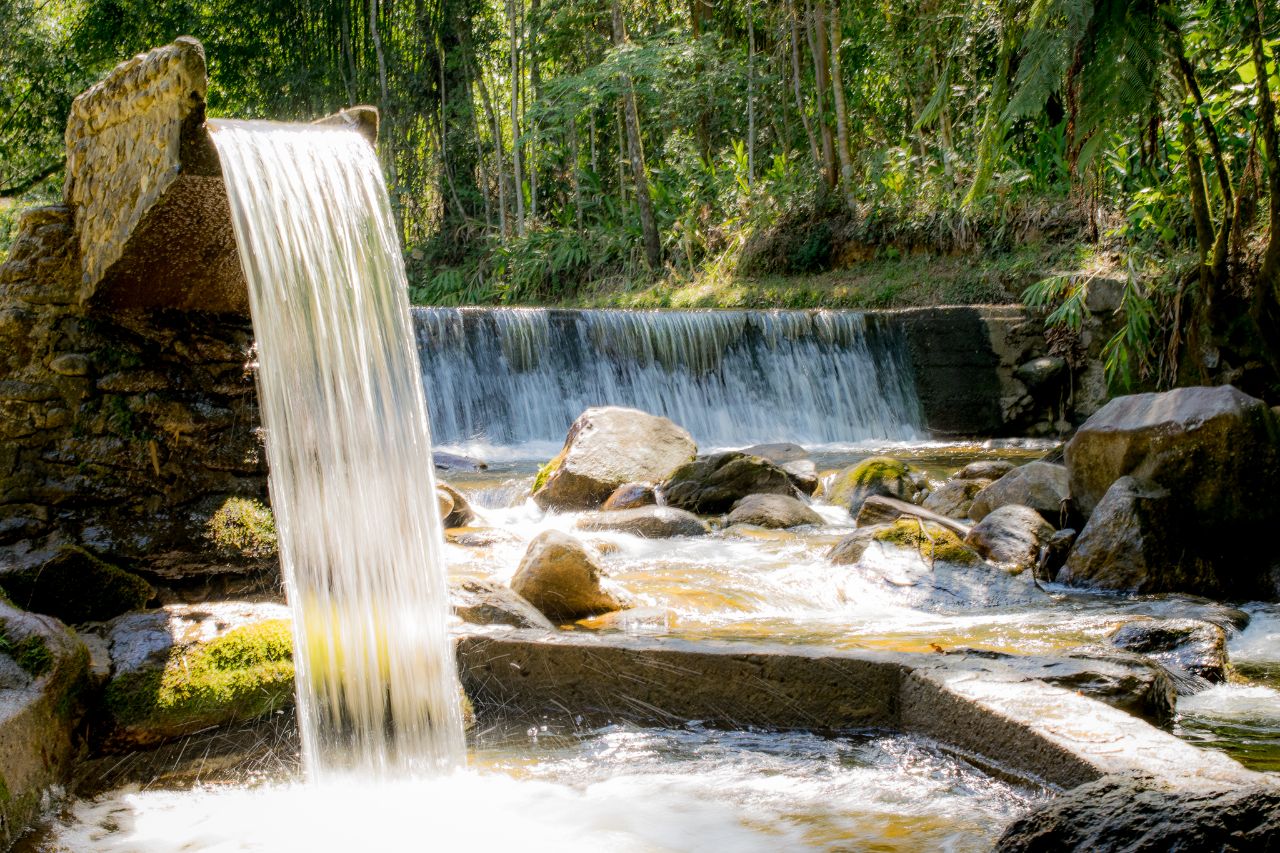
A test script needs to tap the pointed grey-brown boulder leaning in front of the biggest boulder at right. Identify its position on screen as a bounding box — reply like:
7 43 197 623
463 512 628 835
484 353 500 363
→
1057 476 1226 593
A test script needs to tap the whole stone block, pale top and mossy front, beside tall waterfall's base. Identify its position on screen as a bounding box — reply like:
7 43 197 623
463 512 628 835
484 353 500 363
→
100 602 293 751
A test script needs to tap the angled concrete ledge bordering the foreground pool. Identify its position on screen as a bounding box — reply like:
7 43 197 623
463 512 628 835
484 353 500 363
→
457 630 1274 789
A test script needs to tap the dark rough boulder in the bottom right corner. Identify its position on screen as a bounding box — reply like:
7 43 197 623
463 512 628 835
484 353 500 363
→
996 776 1280 853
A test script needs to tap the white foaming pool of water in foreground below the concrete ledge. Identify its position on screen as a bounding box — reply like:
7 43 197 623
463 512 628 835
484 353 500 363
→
40 727 1036 853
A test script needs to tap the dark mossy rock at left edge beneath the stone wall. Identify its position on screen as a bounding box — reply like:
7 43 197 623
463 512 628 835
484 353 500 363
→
0 546 155 625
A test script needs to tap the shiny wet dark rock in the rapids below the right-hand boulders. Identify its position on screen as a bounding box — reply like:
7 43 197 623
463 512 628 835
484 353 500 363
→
1108 619 1226 693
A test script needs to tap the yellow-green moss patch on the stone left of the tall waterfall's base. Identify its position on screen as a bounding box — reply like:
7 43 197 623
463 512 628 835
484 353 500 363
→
105 620 293 736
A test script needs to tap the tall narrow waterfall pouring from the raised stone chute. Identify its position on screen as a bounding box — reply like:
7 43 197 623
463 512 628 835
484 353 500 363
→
211 122 463 779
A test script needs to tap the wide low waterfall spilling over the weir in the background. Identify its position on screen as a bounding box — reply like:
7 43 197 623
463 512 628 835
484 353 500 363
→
413 307 922 447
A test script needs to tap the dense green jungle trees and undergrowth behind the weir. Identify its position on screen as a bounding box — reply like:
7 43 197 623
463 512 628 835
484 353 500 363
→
0 0 1280 388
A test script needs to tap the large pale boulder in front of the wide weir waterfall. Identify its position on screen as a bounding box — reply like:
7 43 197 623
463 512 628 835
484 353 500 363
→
534 406 698 510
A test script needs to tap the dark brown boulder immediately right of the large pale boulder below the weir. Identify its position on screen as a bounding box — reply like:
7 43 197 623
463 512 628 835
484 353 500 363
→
662 451 795 515
